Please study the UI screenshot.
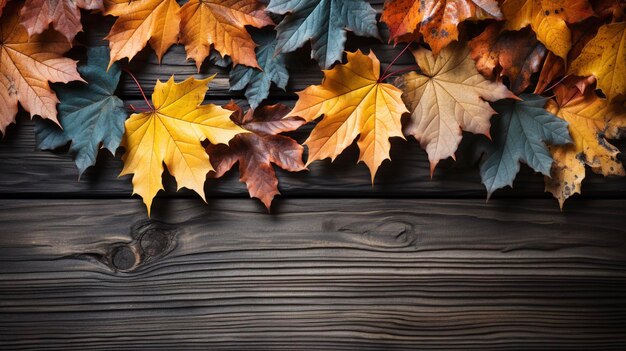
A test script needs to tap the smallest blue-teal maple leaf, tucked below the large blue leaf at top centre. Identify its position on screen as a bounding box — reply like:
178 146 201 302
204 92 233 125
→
230 31 289 109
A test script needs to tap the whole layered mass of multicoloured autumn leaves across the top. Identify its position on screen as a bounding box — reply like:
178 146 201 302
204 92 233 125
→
0 0 626 212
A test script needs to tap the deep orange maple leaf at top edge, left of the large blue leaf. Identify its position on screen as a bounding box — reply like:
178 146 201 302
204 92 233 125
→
180 0 274 70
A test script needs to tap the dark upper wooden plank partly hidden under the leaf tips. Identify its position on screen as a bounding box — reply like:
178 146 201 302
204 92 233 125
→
0 116 626 201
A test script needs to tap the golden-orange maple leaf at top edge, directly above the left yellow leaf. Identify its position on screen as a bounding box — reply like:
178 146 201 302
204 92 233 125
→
104 0 180 64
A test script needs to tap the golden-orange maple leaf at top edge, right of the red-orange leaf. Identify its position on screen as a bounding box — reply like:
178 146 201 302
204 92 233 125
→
502 0 594 59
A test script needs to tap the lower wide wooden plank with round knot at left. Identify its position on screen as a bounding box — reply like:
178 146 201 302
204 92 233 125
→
0 199 626 351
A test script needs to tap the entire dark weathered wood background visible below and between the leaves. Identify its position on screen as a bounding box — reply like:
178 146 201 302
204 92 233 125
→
0 1 626 351
